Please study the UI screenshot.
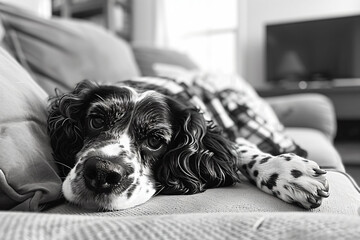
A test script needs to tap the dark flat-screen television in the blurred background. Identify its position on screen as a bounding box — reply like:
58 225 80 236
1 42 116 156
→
266 15 360 86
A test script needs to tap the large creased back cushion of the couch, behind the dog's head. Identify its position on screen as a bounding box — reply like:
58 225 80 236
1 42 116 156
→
0 4 139 94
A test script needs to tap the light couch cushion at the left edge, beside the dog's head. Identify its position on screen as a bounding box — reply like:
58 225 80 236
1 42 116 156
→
0 45 61 210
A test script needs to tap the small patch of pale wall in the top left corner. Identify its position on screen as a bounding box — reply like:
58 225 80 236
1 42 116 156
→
0 0 51 18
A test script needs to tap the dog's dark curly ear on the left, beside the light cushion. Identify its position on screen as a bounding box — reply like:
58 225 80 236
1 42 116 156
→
48 80 97 176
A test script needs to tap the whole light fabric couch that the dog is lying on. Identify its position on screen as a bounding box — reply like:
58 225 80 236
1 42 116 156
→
0 4 360 240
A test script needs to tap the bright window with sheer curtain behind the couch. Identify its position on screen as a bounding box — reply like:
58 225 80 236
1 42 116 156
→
148 0 238 73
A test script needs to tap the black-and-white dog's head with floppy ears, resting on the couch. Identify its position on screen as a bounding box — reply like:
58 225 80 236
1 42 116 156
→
48 81 237 210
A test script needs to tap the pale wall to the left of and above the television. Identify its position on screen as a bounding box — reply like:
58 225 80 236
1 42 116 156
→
245 0 360 86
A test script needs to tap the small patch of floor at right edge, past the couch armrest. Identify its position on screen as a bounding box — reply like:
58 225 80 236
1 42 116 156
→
335 141 360 185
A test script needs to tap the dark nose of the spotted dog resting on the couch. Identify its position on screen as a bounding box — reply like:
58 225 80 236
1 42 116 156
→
83 157 125 192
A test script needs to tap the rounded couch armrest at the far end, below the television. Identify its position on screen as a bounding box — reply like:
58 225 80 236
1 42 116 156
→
265 93 337 141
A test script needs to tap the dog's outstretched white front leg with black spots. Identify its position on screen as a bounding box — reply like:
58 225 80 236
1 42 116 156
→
236 140 329 209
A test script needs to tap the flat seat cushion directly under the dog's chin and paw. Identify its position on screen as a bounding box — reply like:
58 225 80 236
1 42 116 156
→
48 170 360 217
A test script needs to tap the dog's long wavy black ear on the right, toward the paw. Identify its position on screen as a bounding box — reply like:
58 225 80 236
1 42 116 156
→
154 100 238 194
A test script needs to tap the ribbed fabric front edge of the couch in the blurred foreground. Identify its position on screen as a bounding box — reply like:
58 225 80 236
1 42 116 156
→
0 212 360 240
